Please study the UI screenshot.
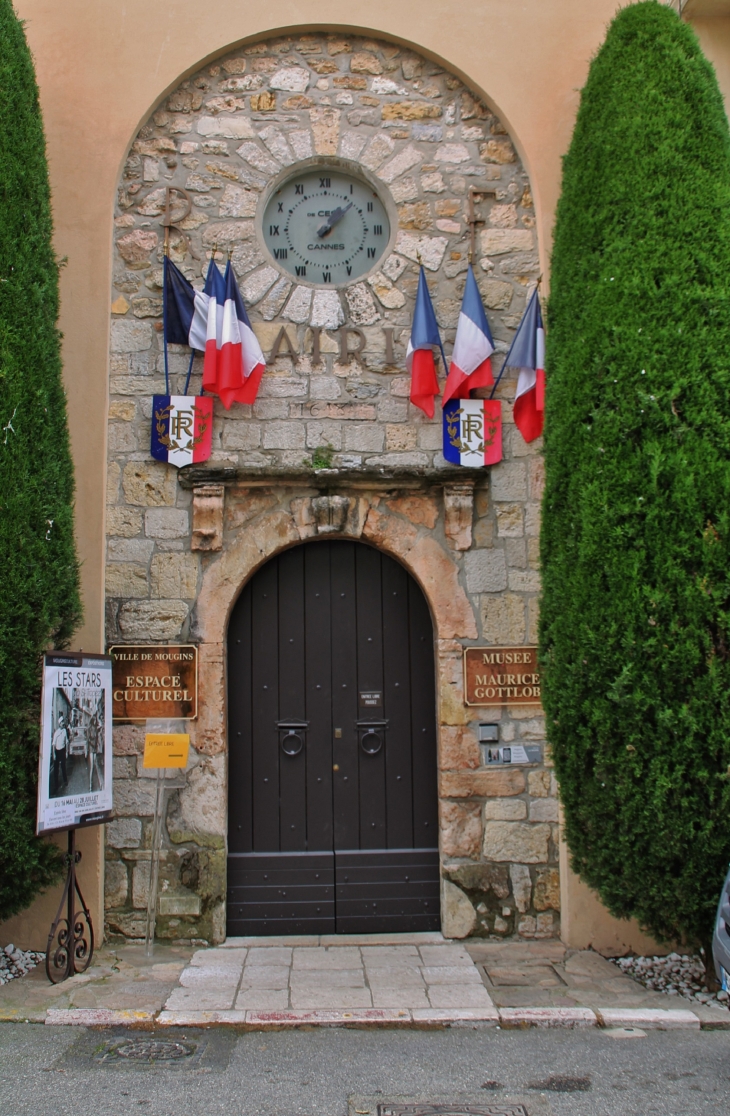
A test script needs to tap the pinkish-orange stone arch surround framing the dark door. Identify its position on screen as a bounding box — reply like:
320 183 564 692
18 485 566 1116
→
186 483 479 941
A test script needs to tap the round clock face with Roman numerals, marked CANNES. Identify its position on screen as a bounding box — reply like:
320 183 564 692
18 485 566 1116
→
262 166 391 287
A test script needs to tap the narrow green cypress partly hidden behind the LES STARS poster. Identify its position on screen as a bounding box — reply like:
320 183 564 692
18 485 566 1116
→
0 0 80 918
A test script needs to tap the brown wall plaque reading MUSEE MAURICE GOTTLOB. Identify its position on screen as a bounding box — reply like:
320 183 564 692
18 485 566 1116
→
464 647 540 706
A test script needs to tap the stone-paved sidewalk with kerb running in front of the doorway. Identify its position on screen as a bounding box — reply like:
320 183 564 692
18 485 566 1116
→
0 933 730 1030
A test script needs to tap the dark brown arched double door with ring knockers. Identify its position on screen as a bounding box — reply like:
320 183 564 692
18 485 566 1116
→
228 540 439 935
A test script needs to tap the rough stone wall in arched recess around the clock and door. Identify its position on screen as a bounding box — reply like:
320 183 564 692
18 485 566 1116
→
106 36 559 940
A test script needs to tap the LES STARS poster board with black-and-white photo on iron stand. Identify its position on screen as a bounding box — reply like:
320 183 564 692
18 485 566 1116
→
37 652 112 833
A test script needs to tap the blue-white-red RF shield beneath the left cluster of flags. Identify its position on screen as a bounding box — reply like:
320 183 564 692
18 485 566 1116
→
150 395 213 469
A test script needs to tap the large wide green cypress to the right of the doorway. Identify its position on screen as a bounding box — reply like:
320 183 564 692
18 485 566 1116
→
540 0 730 945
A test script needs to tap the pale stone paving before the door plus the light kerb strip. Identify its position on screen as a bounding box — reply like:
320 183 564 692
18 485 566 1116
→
35 934 730 1030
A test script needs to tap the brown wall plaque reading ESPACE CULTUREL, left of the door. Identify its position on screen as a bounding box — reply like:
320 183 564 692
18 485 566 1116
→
109 644 198 721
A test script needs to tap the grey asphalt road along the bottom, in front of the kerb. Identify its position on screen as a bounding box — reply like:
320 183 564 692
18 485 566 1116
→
0 1023 730 1116
